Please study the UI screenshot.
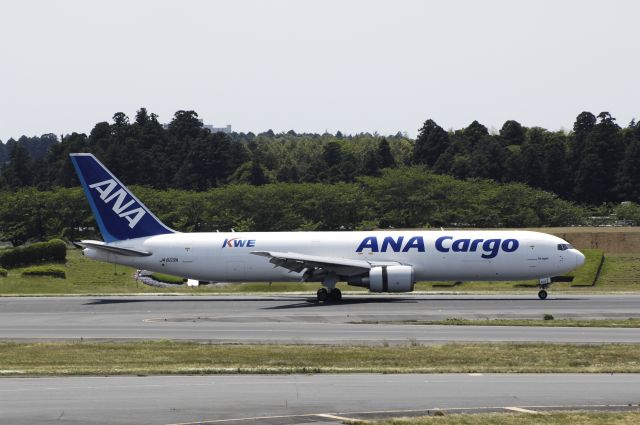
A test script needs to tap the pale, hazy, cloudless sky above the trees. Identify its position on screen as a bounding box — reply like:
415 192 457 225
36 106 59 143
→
0 0 640 142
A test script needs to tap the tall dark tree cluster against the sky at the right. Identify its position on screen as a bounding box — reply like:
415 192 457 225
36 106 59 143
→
413 112 640 205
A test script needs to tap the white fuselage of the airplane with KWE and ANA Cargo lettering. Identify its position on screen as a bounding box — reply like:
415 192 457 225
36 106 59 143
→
84 230 584 282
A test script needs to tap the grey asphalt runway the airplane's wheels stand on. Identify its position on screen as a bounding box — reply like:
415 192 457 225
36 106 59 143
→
0 294 640 344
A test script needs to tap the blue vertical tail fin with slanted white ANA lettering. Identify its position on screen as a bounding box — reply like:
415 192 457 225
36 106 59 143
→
71 153 174 242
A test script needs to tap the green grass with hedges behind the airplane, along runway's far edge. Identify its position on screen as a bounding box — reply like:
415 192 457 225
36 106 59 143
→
0 249 640 296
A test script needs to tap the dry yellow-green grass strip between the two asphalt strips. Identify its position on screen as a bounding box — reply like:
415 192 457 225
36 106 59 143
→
0 341 640 376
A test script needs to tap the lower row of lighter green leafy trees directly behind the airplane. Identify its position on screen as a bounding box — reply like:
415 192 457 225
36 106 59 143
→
0 167 587 246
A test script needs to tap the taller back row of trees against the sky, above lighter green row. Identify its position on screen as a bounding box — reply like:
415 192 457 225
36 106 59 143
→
0 108 640 205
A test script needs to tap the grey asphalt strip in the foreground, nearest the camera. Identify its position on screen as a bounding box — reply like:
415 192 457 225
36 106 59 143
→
0 374 640 425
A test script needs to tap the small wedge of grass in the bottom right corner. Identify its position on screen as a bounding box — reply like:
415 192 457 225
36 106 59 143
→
370 411 640 425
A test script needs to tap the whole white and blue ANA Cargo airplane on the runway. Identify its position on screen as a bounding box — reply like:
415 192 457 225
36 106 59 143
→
70 153 585 302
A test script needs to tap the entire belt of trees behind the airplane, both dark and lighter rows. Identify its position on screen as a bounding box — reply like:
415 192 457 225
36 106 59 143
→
0 108 640 244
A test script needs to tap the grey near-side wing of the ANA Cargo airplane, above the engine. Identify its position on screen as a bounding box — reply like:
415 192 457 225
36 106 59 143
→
251 251 399 276
